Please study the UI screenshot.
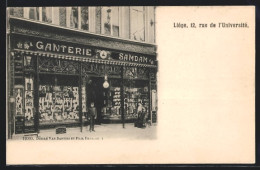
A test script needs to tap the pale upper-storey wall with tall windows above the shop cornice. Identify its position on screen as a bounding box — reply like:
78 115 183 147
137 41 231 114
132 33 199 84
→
10 6 155 42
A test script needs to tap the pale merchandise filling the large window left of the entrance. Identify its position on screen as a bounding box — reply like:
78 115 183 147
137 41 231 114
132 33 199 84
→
39 85 79 124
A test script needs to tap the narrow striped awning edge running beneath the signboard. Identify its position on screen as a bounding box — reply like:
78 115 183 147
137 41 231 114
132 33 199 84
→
14 49 157 68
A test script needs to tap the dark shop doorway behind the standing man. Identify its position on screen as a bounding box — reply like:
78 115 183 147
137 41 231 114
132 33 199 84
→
86 77 107 124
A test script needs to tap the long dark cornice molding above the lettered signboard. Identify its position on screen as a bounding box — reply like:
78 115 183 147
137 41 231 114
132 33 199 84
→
11 20 156 55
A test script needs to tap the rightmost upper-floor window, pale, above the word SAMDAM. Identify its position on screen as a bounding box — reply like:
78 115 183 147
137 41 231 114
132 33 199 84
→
130 7 145 41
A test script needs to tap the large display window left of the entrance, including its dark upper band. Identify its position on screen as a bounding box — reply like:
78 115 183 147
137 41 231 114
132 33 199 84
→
39 75 79 125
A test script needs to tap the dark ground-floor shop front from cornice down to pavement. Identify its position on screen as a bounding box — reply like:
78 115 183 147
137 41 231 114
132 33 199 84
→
7 17 158 137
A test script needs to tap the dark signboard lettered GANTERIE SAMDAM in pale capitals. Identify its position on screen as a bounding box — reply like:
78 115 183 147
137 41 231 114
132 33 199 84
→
12 36 156 65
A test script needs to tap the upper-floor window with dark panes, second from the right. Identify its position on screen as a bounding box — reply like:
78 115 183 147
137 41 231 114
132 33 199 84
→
101 7 119 37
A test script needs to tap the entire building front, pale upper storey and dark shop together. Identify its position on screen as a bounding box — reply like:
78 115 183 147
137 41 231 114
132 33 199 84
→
6 6 158 138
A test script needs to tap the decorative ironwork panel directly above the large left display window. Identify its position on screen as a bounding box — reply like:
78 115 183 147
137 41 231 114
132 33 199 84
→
39 57 79 74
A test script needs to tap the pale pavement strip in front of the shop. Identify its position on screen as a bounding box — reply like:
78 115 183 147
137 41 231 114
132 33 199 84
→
11 123 157 140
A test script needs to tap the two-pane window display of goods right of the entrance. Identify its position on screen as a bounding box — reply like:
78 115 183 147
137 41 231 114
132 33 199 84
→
102 79 149 120
